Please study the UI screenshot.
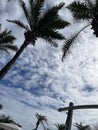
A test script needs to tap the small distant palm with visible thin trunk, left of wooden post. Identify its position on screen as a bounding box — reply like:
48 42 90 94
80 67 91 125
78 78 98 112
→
34 113 47 130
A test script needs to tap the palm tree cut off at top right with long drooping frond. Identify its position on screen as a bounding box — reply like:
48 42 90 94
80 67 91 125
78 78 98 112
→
62 0 98 61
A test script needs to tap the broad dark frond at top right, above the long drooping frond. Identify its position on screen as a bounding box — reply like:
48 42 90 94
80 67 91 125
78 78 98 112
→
67 1 93 20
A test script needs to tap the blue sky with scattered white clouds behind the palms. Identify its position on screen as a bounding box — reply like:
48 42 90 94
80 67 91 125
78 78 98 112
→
0 0 98 130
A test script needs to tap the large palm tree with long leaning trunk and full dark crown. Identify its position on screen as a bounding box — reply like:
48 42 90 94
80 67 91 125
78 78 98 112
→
0 0 69 79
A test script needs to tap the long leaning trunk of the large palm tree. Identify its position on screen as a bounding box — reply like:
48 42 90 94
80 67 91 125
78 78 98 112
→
0 40 29 80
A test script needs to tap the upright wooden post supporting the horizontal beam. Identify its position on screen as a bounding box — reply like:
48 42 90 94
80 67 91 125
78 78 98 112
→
65 102 74 130
